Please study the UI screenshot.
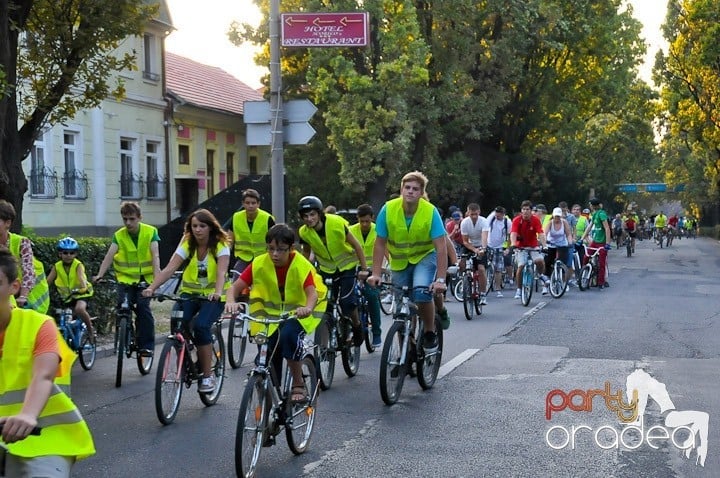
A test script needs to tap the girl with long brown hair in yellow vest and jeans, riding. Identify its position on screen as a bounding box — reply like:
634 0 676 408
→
147 209 233 393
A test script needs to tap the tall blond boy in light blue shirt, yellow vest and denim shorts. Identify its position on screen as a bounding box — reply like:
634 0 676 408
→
368 171 448 353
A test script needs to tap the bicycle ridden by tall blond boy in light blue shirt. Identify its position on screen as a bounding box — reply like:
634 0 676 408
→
380 286 443 405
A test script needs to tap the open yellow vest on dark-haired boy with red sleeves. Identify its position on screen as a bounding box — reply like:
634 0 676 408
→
250 252 327 335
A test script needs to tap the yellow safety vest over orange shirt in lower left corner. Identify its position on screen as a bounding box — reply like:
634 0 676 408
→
0 309 95 459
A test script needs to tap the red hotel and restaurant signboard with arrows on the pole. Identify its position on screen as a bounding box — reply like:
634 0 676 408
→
281 12 370 47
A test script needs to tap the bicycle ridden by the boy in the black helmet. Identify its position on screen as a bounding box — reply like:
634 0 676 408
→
315 278 360 390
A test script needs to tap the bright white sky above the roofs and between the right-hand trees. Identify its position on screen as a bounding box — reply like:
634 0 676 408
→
165 0 666 88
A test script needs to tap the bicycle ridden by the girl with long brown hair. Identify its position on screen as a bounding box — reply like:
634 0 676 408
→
153 294 225 425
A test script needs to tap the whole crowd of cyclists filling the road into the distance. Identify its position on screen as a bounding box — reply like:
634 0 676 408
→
0 171 697 476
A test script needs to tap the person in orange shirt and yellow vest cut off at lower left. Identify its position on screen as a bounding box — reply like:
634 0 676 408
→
0 251 95 478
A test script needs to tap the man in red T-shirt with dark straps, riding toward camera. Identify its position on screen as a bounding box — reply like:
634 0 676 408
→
510 200 548 299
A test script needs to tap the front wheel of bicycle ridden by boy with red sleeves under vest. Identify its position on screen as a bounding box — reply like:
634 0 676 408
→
235 375 270 477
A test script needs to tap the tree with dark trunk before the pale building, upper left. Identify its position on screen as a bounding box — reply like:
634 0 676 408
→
0 0 157 230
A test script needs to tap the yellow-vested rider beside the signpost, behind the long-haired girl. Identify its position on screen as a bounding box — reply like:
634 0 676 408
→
229 189 275 272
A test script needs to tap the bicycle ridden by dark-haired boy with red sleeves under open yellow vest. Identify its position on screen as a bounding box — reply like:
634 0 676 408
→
235 313 319 478
